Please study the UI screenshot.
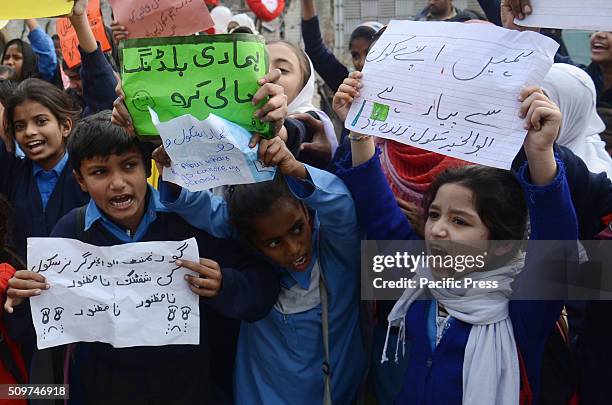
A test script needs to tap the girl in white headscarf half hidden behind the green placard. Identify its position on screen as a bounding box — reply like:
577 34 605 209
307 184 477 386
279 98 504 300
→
267 41 338 168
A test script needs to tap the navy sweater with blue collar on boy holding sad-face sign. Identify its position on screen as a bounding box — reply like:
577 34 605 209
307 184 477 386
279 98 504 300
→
51 186 280 404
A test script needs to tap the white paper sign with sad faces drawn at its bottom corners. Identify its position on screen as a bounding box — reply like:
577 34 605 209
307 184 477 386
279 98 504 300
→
28 238 200 349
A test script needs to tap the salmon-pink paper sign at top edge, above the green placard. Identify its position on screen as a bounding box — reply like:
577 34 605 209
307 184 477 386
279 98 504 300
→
110 0 214 38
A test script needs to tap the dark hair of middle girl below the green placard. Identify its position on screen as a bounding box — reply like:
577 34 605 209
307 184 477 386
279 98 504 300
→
225 172 300 237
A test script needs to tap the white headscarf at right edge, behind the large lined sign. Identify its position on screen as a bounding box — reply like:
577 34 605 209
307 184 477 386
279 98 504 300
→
542 63 612 179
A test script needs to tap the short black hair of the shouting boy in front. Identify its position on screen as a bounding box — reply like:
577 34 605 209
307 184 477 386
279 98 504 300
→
67 111 151 177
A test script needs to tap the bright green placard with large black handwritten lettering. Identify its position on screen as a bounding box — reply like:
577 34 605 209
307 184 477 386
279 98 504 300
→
121 34 272 137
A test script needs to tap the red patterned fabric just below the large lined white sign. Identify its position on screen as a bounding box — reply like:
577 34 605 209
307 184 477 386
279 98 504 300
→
385 141 473 204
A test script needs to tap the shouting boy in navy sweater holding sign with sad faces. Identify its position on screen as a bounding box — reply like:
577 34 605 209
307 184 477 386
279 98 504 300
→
5 112 279 404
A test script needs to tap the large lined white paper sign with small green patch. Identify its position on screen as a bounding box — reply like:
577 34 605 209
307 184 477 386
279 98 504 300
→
345 21 558 169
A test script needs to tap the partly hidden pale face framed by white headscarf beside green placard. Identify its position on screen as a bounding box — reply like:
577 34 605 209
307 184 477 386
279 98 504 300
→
268 43 302 104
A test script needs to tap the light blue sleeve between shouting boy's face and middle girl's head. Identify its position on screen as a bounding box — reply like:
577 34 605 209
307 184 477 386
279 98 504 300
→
159 182 239 239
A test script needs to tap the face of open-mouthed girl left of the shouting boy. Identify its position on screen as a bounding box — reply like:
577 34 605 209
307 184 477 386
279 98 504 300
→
13 101 72 170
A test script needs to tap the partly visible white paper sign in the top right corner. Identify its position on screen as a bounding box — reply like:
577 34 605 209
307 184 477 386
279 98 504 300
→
514 0 612 31
